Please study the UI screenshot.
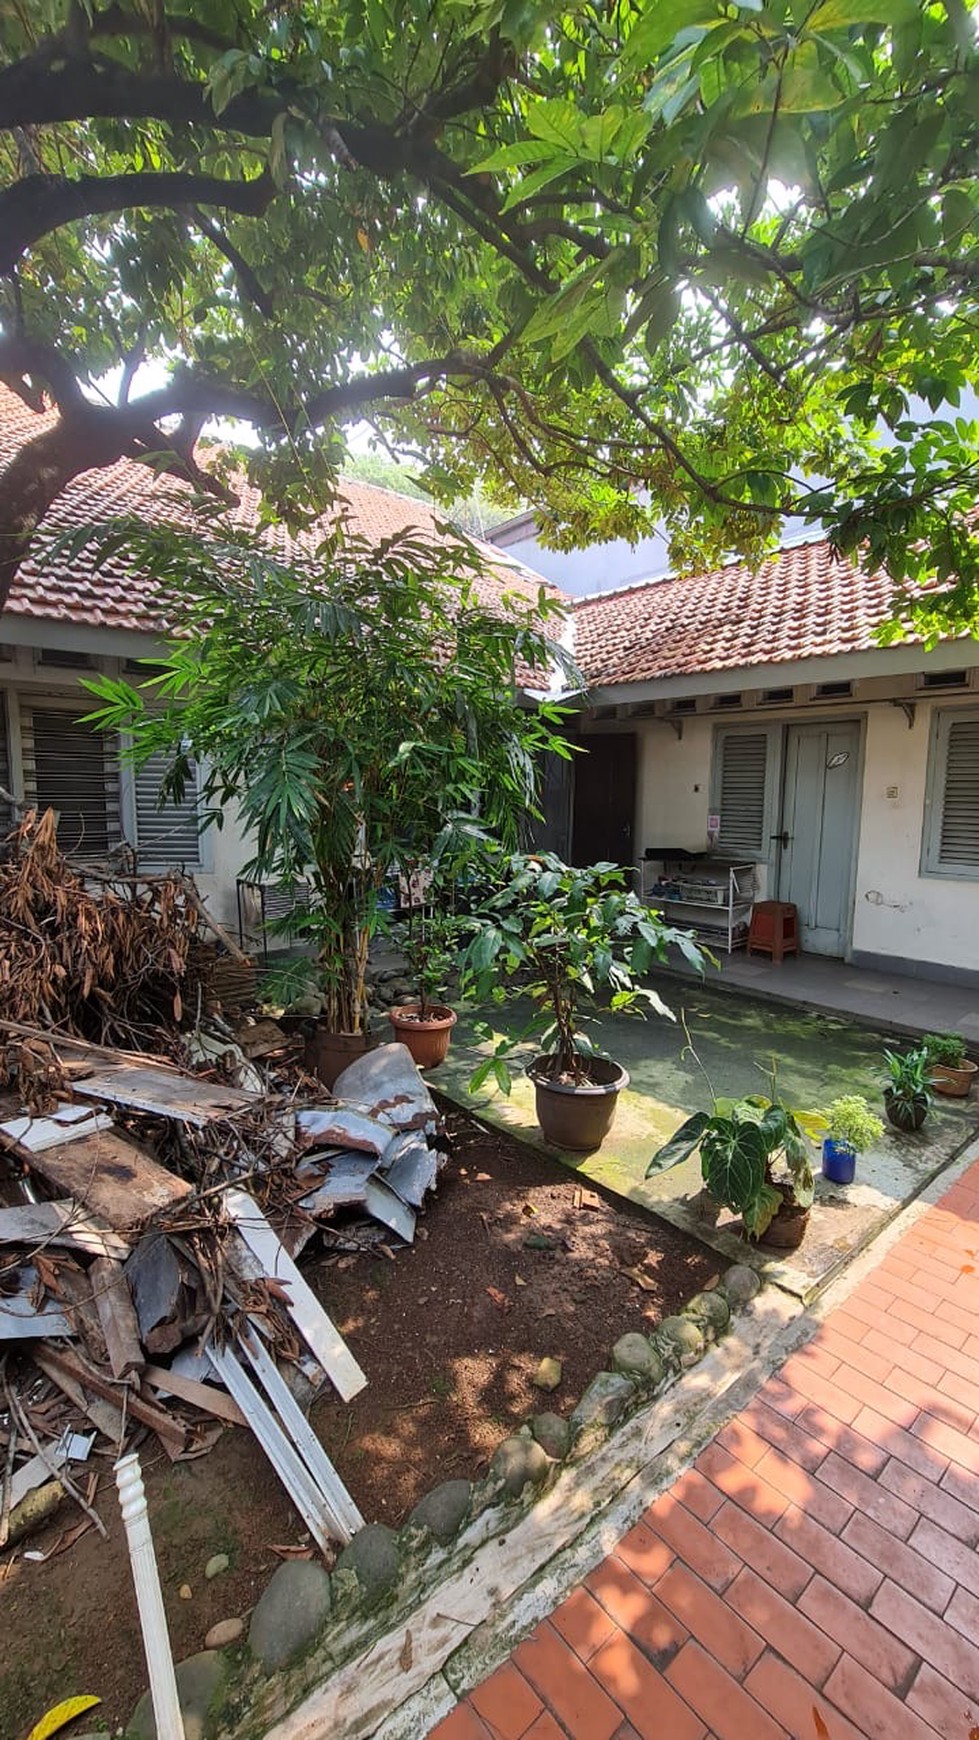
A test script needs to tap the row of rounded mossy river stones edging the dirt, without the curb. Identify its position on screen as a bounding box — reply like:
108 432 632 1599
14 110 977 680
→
129 1263 775 1740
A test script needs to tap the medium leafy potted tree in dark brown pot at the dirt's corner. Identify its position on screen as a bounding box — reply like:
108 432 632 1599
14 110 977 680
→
463 853 704 1152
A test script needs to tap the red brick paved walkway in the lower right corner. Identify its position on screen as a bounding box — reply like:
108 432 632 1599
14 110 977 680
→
435 1164 979 1740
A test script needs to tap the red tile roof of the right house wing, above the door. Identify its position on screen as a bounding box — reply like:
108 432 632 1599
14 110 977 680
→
574 539 894 687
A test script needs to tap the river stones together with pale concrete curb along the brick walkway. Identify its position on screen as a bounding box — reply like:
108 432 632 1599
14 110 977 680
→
124 1263 803 1740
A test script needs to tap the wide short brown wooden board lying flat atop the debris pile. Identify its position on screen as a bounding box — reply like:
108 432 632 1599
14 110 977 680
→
28 1129 191 1232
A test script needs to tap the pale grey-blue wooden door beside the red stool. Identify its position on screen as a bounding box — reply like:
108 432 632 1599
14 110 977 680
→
777 720 861 955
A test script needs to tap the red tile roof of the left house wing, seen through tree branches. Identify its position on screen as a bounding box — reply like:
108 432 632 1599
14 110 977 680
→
0 386 560 635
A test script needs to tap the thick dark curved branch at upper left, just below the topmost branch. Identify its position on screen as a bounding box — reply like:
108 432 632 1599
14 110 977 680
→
0 171 276 277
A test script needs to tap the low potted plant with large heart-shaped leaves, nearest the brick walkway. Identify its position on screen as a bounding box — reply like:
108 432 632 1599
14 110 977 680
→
645 1075 826 1249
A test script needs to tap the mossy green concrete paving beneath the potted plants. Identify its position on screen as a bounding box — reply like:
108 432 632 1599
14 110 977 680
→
438 980 979 1300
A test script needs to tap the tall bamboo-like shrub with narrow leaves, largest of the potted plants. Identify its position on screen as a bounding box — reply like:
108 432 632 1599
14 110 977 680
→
89 525 569 1086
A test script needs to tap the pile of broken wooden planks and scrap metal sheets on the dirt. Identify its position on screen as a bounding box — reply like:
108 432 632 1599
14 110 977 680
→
0 1016 445 1547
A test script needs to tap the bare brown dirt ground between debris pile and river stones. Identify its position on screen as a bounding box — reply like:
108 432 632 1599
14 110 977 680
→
0 1112 718 1740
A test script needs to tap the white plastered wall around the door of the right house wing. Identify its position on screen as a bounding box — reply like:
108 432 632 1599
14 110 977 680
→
583 686 979 976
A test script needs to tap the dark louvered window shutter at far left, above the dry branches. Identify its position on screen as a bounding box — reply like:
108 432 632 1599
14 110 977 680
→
21 706 122 858
